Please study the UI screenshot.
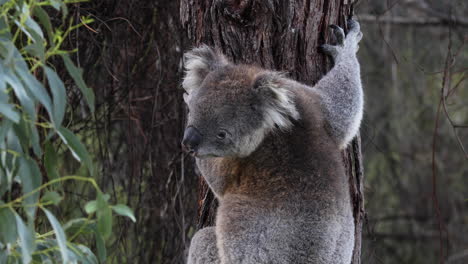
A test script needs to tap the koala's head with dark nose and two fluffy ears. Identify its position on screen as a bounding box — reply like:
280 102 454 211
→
182 46 299 158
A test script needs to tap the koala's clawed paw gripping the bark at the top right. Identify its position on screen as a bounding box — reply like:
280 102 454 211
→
319 19 362 62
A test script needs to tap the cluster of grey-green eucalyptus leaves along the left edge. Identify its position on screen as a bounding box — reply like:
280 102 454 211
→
0 0 135 263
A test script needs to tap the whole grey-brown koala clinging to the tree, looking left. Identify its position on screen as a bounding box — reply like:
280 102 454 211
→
182 20 363 264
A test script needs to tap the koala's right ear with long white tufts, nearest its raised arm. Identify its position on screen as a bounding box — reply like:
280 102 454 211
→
253 72 299 129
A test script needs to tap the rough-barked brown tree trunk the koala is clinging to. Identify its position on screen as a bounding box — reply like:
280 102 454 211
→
180 0 364 264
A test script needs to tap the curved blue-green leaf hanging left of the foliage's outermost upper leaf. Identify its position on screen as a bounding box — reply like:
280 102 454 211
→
44 66 67 127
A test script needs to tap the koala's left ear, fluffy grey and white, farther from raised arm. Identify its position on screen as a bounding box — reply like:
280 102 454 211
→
182 45 229 94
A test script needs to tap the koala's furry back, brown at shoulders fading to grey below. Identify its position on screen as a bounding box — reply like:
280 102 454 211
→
209 87 354 263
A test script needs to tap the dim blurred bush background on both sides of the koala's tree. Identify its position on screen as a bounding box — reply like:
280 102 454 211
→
0 0 468 263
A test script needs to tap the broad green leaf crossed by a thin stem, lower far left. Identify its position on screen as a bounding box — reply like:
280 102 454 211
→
18 158 42 218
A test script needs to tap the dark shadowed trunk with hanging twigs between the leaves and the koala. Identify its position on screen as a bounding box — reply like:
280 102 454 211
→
74 0 197 264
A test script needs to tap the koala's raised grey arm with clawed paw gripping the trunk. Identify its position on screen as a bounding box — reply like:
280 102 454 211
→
313 20 364 148
